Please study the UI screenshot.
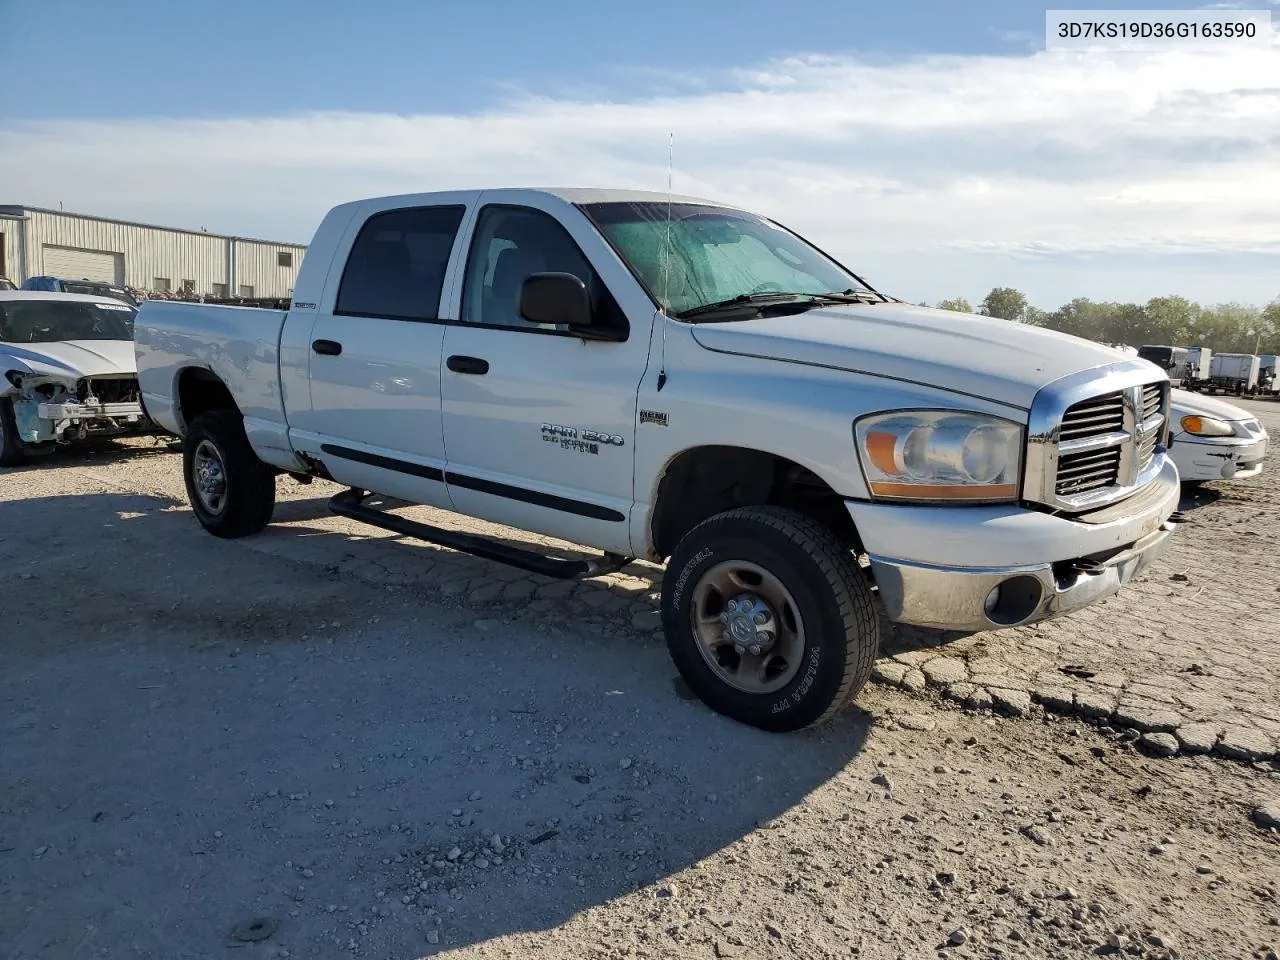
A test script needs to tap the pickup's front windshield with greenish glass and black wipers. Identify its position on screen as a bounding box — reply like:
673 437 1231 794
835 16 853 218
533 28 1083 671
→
582 202 870 315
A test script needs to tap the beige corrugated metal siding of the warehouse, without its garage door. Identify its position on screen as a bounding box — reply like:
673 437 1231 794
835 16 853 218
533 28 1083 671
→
0 209 306 297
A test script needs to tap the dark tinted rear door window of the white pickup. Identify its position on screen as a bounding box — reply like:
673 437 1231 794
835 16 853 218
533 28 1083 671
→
333 206 466 320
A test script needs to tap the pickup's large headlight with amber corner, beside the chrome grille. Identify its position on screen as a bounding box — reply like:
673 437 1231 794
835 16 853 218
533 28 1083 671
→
854 410 1023 503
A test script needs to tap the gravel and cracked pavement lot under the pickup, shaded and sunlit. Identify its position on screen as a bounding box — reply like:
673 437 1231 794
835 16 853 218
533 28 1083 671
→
0 403 1280 960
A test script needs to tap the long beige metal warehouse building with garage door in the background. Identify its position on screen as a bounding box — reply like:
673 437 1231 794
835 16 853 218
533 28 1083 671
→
0 206 306 297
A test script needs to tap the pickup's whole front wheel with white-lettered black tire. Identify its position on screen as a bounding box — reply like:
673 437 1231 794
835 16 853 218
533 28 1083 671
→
662 507 879 731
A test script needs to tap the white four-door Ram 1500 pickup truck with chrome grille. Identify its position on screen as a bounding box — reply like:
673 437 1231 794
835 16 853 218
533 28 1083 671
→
137 189 1179 730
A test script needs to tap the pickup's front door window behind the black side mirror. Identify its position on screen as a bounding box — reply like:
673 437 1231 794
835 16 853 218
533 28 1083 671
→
462 206 626 330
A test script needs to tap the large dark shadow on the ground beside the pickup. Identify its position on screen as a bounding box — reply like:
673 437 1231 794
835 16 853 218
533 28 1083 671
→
0 494 874 957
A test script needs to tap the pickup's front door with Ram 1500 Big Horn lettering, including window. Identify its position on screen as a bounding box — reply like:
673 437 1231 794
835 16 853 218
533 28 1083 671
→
440 204 649 553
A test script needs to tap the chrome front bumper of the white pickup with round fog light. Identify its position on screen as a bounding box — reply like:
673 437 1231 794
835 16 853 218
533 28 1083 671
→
870 521 1174 631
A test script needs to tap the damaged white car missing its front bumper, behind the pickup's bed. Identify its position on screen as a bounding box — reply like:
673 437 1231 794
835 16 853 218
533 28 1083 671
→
0 291 155 467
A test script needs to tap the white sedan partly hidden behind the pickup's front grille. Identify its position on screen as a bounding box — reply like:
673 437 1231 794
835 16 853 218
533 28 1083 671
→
1169 390 1267 484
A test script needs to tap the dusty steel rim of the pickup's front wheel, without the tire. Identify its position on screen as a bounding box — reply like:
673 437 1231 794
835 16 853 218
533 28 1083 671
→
690 561 805 695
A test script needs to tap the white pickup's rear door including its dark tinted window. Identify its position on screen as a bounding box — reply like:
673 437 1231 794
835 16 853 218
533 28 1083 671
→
291 197 467 507
